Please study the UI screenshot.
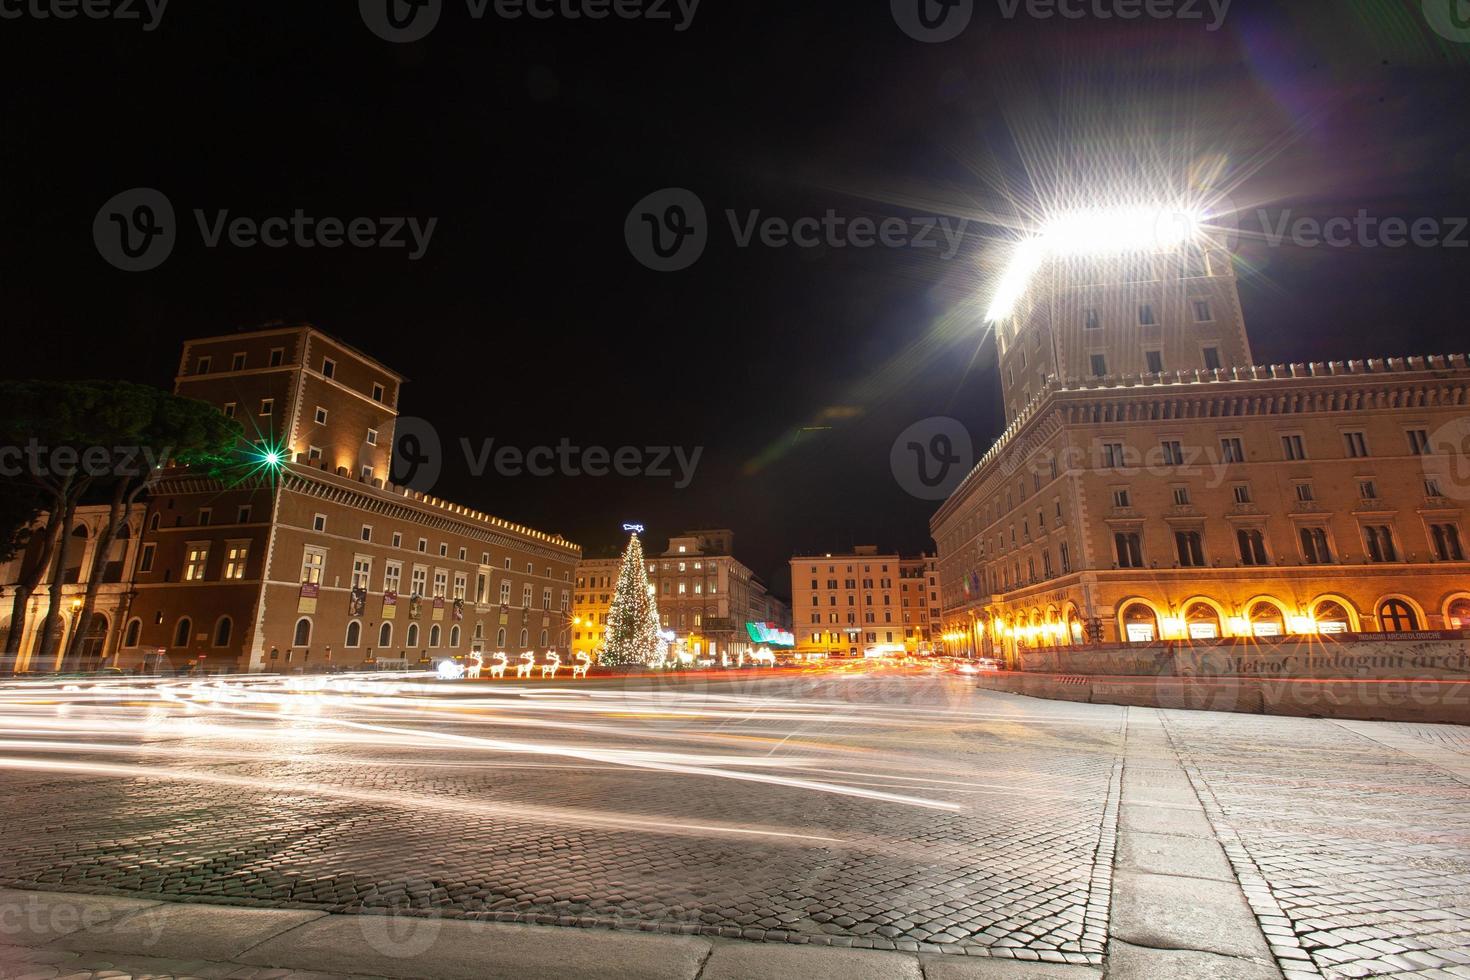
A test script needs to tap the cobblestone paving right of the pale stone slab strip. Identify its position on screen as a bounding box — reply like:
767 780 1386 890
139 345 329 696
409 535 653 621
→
1164 711 1470 977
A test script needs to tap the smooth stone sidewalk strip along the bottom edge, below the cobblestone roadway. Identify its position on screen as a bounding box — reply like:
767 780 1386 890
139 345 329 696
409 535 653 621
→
0 890 1103 980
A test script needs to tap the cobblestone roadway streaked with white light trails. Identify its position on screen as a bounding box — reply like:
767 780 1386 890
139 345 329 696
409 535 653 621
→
0 673 1123 962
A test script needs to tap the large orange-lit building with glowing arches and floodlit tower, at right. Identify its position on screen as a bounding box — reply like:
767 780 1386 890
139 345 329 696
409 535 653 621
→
931 207 1470 655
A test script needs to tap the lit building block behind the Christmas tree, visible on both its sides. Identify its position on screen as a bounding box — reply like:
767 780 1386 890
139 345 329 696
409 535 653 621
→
572 529 791 658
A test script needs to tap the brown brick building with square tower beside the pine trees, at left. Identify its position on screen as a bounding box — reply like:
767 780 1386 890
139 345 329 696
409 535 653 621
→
111 326 581 671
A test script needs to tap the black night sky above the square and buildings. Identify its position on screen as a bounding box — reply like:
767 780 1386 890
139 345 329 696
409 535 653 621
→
0 0 1470 599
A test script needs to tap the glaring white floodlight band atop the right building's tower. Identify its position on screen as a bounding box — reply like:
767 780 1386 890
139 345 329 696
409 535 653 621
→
985 207 1202 323
